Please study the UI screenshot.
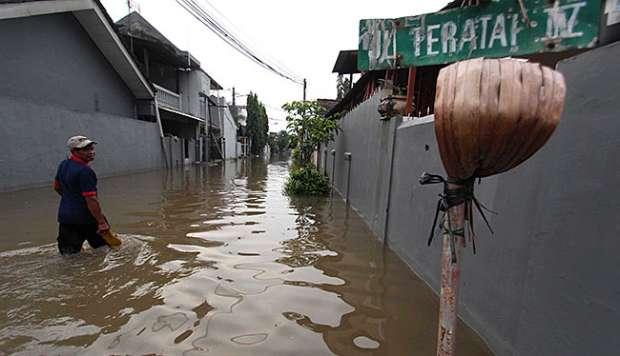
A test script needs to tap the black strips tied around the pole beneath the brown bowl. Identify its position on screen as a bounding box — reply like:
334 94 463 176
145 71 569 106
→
419 172 497 263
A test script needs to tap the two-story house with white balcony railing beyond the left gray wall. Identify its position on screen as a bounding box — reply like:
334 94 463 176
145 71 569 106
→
116 12 232 165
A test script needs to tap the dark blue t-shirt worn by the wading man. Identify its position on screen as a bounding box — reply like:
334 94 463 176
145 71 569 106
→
54 156 97 224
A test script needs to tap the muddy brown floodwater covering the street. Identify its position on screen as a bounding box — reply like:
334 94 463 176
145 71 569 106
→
0 161 490 356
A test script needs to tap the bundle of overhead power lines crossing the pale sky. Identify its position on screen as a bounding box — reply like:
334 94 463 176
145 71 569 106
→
176 0 303 85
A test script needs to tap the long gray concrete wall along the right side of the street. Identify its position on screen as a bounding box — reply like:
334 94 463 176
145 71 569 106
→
327 43 620 355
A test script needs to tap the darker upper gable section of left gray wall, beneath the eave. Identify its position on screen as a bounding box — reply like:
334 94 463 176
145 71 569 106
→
0 13 136 120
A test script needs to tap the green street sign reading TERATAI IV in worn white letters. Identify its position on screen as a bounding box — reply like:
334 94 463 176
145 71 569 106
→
357 0 602 71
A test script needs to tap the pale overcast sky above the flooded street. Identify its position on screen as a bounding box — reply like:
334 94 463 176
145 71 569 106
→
102 0 448 131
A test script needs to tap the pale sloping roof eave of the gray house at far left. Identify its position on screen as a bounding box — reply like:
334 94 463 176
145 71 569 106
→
0 0 154 99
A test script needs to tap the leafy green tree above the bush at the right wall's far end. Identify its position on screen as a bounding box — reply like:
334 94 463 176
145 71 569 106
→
282 101 338 167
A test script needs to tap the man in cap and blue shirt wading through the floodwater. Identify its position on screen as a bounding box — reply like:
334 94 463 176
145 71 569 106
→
54 136 110 255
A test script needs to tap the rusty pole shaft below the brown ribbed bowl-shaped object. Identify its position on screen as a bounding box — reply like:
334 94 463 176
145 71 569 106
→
437 183 465 356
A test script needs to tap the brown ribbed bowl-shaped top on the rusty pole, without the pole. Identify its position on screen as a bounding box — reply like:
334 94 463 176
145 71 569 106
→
435 58 566 180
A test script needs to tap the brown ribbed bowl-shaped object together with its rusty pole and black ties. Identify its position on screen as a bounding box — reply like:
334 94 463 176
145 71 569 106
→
428 58 566 356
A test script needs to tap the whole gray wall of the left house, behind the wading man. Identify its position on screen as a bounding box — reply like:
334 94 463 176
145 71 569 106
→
0 13 163 191
